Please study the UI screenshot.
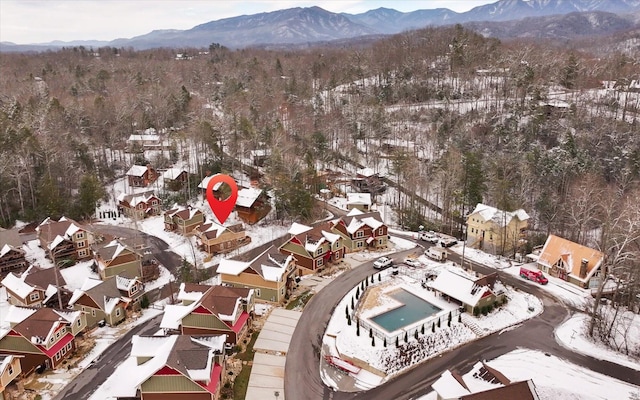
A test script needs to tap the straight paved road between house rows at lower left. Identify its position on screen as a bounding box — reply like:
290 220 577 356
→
53 315 162 400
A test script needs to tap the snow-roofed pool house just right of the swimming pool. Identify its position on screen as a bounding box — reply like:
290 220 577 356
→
428 269 505 315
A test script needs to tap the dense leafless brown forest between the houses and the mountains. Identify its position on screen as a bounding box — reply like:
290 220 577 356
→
0 26 640 318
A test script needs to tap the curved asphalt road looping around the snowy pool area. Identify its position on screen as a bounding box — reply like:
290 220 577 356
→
284 244 640 400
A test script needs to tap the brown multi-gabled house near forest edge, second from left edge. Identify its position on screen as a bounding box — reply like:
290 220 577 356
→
36 217 94 263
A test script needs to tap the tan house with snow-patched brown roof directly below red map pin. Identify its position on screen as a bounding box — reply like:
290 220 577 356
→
192 221 251 254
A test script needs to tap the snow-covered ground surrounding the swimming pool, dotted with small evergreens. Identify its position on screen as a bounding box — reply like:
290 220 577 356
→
322 260 542 389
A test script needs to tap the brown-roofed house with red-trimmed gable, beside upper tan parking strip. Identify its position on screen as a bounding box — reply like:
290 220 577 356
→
160 283 254 345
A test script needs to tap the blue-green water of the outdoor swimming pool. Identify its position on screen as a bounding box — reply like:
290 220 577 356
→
371 289 442 332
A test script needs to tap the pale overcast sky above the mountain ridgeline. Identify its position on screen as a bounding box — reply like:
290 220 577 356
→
0 0 497 44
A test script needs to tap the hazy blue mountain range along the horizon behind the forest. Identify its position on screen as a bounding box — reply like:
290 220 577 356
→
0 0 640 51
